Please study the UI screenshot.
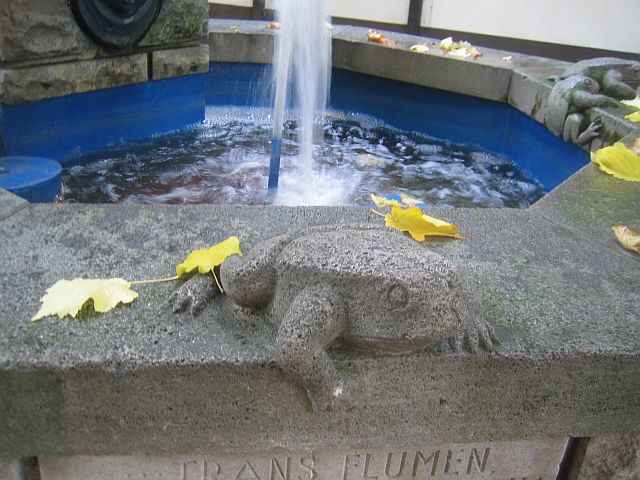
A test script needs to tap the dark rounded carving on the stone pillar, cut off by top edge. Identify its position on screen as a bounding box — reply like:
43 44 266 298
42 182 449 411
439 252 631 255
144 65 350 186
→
70 0 162 49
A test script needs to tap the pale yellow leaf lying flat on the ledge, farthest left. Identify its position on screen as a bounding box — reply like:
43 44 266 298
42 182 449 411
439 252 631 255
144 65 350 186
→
31 278 138 321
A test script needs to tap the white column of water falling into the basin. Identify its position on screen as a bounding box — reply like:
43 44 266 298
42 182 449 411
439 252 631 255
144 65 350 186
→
271 0 336 205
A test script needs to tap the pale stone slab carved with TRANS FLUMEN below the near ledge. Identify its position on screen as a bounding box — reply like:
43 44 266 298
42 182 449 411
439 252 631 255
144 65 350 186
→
40 439 567 480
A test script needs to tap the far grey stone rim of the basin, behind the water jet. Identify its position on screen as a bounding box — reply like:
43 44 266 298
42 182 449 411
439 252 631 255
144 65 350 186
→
209 20 640 146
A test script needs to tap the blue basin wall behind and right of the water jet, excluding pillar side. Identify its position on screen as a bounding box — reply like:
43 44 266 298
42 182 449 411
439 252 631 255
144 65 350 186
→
207 63 589 191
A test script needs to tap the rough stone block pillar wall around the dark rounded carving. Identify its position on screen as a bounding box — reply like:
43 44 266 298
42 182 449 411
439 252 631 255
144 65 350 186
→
0 0 209 104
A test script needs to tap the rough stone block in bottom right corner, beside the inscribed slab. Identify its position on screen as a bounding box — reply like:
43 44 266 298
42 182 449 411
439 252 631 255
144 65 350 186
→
575 431 640 480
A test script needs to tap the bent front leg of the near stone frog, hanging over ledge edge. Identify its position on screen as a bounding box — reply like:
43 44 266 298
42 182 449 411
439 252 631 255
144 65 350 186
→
275 288 346 410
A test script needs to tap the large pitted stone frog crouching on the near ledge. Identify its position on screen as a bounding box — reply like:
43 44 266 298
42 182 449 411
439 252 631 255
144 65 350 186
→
170 226 497 409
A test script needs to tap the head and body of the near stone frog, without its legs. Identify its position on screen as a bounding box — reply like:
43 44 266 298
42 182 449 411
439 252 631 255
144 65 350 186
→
274 229 468 350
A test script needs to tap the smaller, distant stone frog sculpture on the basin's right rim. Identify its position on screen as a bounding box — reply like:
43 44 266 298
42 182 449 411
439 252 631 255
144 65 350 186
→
544 58 640 145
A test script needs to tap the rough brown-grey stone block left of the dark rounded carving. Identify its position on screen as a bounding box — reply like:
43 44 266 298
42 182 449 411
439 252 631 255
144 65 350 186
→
0 0 97 65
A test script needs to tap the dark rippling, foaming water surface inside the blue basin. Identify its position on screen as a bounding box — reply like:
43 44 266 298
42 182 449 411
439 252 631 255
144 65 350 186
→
60 108 545 208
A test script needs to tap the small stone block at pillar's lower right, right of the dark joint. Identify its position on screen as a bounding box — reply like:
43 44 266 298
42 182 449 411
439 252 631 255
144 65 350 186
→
151 45 209 80
